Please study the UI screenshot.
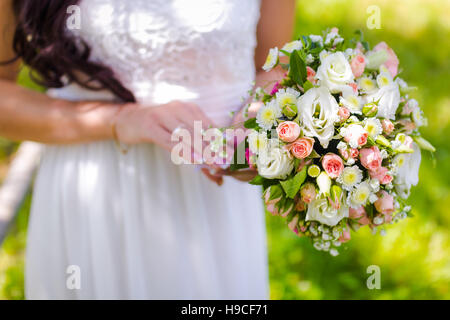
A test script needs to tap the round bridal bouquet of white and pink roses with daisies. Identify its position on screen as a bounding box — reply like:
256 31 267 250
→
231 28 434 255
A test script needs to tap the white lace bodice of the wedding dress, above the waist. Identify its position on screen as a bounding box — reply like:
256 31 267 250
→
72 0 259 113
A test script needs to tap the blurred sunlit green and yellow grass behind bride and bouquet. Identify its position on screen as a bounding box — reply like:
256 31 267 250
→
0 0 450 299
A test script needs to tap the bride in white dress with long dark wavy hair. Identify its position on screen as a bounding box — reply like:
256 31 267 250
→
0 0 295 299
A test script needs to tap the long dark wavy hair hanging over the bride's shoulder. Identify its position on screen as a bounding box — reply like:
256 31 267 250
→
8 0 135 102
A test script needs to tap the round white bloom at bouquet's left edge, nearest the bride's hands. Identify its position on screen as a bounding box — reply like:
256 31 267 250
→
256 147 294 179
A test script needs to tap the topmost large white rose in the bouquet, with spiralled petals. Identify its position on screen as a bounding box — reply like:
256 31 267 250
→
316 51 354 93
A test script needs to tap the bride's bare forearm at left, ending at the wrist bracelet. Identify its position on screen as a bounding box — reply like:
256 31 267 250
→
0 80 119 144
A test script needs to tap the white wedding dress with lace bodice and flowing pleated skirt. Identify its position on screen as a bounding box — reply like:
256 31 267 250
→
26 0 268 299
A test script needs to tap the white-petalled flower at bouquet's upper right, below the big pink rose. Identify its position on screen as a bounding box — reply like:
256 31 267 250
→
366 82 400 120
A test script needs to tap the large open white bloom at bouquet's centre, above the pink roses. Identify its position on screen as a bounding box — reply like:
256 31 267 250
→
297 87 339 148
